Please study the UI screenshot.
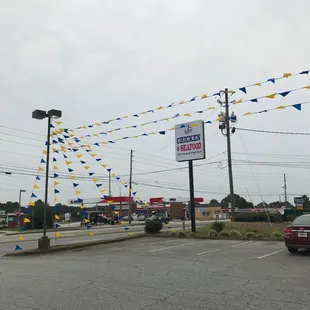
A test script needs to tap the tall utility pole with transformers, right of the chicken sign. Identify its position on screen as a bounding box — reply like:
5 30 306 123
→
218 88 237 221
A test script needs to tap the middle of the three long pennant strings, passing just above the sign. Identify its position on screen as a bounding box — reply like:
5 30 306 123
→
52 85 310 140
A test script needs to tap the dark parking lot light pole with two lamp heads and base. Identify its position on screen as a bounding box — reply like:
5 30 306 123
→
32 110 62 250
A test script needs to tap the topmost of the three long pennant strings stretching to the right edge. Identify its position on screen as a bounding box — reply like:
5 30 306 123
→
67 70 310 130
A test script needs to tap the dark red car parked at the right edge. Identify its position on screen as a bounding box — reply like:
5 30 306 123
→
284 214 310 253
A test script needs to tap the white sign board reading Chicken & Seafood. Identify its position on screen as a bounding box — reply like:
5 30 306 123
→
175 120 206 162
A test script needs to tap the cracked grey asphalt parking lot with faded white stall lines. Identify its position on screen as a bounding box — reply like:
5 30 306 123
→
0 237 310 310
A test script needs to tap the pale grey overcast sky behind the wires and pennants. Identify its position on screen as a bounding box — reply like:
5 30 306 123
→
0 0 310 204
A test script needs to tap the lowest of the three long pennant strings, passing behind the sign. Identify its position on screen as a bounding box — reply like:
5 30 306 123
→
51 102 308 152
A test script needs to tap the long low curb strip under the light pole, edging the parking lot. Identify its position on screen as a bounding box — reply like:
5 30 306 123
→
3 234 146 257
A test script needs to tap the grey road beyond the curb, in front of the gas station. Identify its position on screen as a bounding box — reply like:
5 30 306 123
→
0 221 229 255
